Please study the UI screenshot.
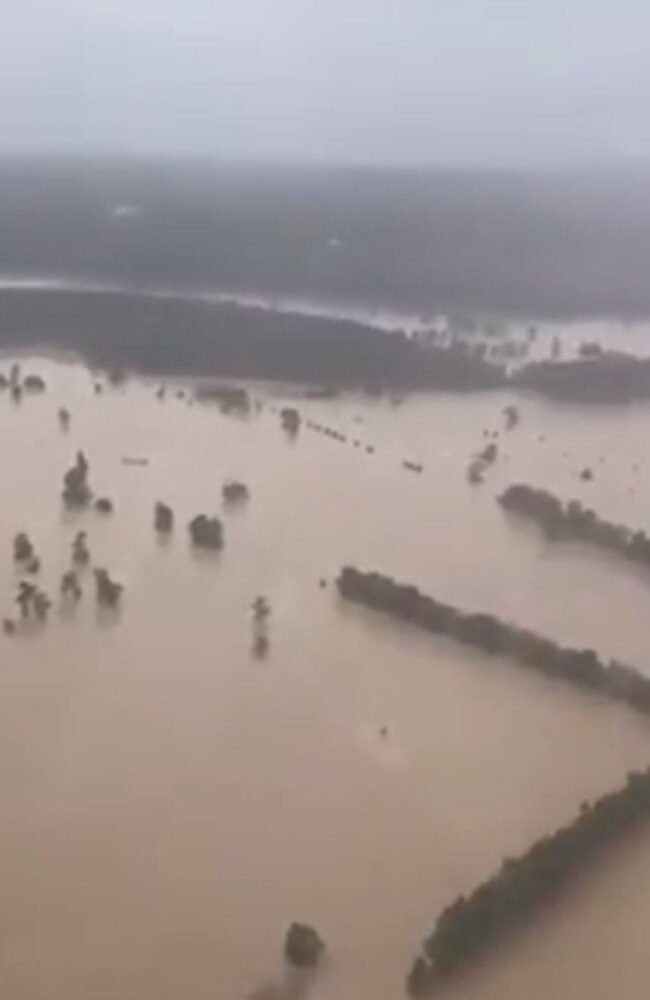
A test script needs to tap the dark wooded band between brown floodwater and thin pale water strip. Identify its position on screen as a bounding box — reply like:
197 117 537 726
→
0 288 650 400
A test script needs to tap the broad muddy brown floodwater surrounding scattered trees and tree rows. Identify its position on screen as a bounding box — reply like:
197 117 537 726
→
0 359 650 1000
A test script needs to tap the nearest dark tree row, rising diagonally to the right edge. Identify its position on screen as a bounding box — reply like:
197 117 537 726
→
407 769 650 996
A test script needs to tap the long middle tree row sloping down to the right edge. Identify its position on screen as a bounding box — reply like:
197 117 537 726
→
337 566 650 713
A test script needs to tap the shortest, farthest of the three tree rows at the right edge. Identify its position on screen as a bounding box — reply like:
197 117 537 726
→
499 483 650 566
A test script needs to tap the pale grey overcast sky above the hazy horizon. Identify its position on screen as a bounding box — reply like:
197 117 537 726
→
0 0 650 166
